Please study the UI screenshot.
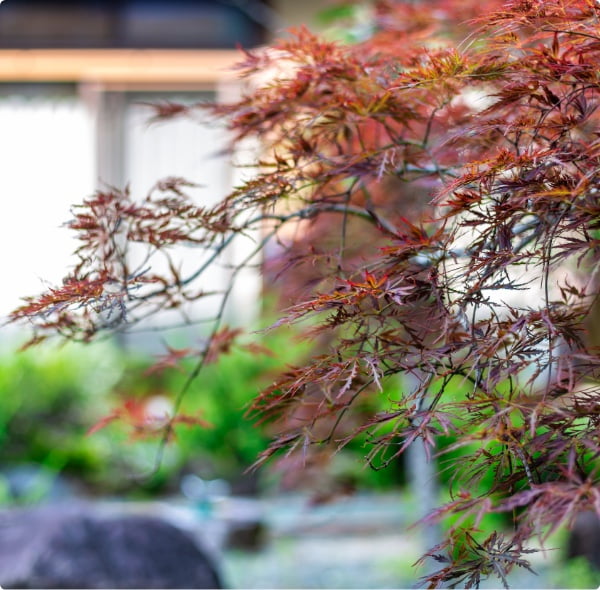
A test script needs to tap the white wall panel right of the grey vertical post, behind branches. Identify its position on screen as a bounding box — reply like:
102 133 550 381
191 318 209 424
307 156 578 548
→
123 95 257 346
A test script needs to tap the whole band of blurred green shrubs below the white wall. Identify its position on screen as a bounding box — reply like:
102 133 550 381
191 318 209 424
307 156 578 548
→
0 330 398 503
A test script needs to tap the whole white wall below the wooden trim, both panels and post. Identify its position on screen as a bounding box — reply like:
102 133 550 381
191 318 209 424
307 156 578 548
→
0 86 260 348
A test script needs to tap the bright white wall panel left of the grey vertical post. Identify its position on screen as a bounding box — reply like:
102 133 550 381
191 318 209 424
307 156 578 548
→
0 93 94 324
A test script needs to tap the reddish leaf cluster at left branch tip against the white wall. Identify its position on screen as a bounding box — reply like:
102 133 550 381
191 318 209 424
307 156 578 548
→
11 178 237 343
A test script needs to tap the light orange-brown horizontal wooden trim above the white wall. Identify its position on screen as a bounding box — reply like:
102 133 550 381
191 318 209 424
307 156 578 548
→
0 49 241 84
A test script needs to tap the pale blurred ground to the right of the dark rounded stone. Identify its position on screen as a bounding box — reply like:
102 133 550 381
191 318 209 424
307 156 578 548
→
92 493 584 590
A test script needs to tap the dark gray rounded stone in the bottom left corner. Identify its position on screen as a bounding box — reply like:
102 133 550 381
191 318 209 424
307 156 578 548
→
0 505 221 588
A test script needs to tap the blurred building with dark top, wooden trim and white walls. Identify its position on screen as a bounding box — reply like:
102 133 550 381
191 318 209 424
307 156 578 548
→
0 0 321 332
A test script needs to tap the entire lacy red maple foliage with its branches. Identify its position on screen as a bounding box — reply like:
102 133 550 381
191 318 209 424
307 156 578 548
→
12 0 600 586
